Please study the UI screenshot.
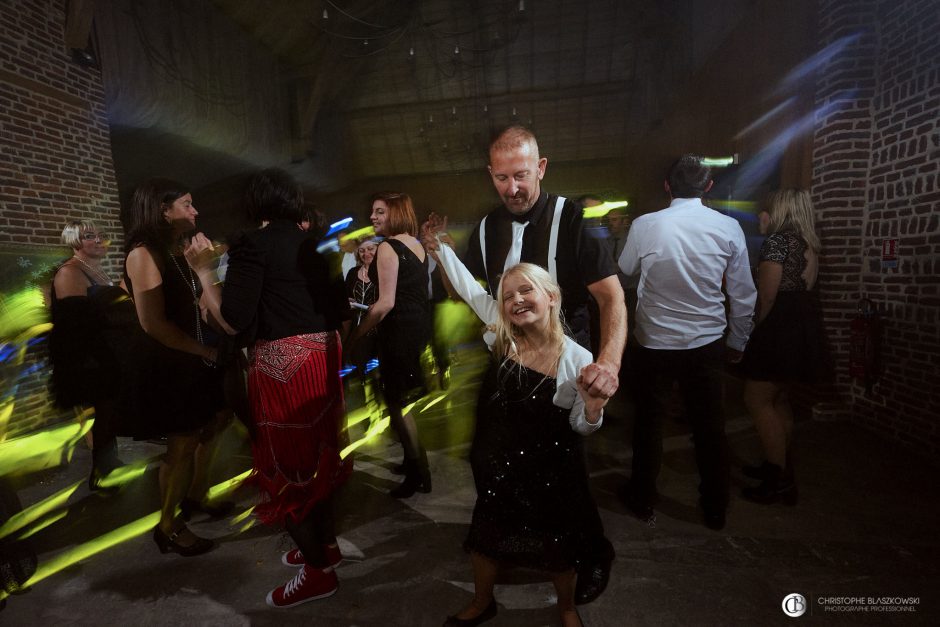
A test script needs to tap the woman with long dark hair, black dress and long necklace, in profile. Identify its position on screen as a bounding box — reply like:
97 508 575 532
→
124 179 225 556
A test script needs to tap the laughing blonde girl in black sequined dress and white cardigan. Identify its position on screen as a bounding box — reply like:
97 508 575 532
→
434 228 607 627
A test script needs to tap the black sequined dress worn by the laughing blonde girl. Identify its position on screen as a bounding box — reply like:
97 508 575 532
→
464 361 596 572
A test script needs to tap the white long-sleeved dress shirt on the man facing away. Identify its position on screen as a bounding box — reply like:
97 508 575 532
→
619 198 757 351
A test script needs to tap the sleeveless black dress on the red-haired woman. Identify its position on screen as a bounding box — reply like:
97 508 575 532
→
369 238 431 406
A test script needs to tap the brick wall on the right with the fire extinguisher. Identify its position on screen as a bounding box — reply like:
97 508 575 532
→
813 0 940 454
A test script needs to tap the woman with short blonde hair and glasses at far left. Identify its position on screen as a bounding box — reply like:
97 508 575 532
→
49 220 122 490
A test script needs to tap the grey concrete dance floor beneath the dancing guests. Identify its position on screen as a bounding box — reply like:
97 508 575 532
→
0 350 940 627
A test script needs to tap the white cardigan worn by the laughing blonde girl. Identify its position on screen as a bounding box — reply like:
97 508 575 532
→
438 242 604 435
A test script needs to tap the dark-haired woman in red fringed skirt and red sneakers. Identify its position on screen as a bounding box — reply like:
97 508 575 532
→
186 169 352 608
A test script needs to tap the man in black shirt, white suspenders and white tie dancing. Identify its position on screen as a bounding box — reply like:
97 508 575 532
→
464 126 627 604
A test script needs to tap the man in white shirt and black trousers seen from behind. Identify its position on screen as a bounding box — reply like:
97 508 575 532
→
619 155 757 529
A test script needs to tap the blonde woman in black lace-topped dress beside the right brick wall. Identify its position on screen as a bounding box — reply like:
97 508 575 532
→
741 190 824 504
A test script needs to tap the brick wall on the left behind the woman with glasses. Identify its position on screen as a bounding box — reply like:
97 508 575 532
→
0 0 122 435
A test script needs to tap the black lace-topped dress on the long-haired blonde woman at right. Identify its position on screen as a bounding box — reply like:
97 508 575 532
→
741 231 829 383
